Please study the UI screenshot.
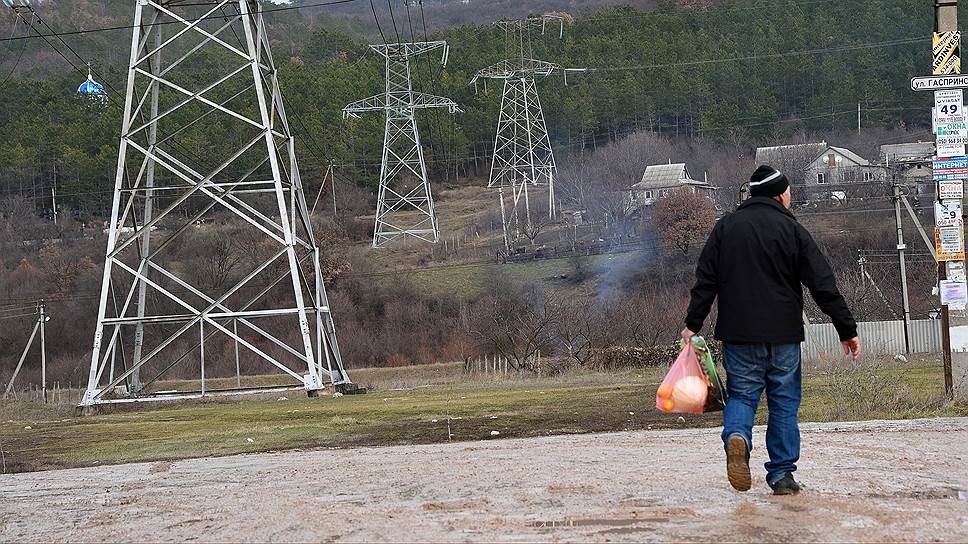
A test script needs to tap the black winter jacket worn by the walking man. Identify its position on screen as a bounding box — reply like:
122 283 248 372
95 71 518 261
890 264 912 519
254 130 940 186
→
686 197 857 344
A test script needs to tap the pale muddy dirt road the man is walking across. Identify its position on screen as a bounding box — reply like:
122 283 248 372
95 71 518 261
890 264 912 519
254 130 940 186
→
0 418 968 542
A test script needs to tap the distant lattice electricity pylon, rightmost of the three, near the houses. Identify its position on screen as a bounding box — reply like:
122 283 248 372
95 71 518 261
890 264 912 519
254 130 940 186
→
471 15 564 249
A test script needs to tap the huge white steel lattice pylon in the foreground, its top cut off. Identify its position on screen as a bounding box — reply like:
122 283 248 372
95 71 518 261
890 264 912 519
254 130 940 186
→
81 0 352 407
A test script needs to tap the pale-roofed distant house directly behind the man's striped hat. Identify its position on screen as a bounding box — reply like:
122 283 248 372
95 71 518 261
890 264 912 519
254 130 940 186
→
756 141 887 189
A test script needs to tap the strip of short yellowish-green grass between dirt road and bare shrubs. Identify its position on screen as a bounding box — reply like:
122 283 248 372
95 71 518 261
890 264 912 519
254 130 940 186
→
0 361 968 473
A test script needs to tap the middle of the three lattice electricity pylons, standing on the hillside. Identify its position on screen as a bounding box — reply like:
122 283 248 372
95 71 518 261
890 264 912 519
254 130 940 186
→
343 41 461 247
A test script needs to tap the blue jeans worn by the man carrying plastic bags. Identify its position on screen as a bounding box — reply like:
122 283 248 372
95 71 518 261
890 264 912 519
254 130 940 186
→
723 344 802 485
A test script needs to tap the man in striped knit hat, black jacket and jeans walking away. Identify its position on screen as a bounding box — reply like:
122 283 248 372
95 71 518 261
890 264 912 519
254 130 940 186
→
682 166 860 495
